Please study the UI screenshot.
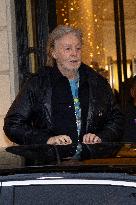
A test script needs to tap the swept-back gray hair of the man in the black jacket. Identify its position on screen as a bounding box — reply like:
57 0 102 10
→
46 25 82 67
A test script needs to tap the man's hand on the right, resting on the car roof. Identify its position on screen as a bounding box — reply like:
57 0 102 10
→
83 133 102 144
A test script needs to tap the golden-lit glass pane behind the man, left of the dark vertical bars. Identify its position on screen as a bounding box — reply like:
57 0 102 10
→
56 0 118 86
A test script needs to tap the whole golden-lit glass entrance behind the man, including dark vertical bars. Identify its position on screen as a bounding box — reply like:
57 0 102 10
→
56 0 136 105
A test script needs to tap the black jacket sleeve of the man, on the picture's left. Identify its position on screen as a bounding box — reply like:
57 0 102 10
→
3 77 49 145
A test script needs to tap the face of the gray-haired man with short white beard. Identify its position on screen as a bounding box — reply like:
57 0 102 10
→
52 33 81 71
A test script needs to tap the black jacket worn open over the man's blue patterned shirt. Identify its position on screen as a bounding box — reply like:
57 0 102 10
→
4 64 123 144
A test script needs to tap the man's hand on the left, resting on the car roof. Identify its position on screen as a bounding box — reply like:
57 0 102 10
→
47 135 72 145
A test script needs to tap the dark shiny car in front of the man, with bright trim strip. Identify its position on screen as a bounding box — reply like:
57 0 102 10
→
0 143 136 205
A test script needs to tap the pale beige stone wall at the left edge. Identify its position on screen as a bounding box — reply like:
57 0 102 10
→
0 0 18 147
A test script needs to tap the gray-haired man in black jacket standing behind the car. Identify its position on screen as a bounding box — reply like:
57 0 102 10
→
4 25 122 147
